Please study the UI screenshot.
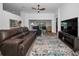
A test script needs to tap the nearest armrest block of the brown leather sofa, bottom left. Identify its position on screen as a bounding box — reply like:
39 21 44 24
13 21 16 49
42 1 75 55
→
1 39 23 56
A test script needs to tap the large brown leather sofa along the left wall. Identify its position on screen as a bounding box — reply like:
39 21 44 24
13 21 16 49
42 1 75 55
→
0 27 36 56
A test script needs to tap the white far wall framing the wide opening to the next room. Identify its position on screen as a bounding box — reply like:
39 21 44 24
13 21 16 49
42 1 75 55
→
21 12 56 33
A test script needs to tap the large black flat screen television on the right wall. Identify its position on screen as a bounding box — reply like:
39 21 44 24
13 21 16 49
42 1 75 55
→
61 17 78 37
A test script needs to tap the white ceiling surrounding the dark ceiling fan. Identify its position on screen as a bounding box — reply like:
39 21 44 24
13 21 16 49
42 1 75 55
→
3 3 62 15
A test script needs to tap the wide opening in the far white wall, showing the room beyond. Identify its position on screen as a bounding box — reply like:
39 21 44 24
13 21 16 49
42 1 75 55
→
29 20 52 34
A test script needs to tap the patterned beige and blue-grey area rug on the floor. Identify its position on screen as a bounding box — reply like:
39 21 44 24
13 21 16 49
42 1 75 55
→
30 36 79 56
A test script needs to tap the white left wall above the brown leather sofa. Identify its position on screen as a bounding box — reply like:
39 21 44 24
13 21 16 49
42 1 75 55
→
0 3 22 29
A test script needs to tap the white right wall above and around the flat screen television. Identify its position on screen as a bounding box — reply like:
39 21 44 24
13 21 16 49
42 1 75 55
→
60 3 79 36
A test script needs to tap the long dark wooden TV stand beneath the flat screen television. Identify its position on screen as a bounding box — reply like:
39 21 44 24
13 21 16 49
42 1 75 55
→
58 31 79 51
